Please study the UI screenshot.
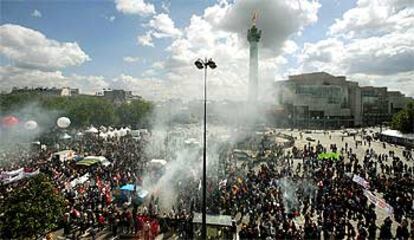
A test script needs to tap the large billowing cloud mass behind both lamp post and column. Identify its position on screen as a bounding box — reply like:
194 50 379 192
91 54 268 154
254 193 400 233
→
137 0 319 99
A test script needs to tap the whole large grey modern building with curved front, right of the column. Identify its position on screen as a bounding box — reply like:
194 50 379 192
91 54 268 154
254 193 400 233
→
275 72 411 128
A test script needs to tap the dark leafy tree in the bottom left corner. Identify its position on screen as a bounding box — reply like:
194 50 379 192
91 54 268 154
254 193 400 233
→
0 174 65 239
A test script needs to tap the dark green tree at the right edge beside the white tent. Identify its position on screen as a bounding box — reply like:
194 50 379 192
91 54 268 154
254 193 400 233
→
391 102 414 133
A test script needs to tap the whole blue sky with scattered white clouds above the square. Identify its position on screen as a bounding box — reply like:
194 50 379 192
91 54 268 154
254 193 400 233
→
0 0 414 98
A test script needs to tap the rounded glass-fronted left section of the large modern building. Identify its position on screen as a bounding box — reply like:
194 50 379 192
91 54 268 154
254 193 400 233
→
276 72 361 127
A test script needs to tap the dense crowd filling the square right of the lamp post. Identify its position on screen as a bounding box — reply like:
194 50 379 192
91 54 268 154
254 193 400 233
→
212 130 414 239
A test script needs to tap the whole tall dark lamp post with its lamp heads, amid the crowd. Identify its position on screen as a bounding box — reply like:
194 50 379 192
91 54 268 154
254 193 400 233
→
194 58 217 240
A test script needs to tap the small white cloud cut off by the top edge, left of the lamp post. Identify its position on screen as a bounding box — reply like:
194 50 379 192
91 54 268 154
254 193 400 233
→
115 0 155 16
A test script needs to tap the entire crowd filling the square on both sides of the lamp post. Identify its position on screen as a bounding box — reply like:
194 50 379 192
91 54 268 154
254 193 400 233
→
0 126 414 239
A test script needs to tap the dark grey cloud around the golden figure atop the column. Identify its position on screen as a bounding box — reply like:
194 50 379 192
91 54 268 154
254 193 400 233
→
204 0 320 52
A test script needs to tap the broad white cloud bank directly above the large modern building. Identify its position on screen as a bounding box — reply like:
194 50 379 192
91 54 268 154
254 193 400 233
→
299 30 414 75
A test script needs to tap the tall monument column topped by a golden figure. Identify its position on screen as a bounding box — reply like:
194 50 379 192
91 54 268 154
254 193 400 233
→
247 13 262 103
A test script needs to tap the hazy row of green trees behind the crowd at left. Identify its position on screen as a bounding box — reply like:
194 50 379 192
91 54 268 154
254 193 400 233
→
0 93 153 128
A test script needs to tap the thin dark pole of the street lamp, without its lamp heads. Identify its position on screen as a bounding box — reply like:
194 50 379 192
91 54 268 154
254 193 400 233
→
201 62 208 240
